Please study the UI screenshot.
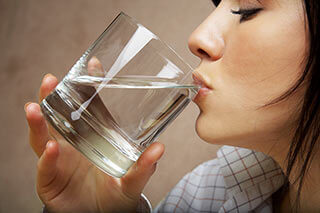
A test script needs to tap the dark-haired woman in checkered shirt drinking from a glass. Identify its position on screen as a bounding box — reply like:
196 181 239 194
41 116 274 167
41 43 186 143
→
25 0 320 212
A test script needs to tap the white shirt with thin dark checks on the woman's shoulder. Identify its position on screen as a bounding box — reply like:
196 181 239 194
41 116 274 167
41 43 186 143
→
139 146 285 213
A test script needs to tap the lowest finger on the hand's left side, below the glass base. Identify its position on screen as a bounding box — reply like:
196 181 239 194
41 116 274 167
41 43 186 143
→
37 141 59 194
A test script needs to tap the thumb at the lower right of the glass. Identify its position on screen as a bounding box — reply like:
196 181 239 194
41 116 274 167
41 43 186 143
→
121 142 164 198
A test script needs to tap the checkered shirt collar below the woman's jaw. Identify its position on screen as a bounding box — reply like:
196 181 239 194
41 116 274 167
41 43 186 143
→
217 146 285 210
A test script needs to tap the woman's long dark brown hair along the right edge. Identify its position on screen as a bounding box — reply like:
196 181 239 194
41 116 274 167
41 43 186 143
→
280 0 320 211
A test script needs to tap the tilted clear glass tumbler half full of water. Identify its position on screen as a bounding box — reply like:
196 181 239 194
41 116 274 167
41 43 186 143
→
41 13 198 177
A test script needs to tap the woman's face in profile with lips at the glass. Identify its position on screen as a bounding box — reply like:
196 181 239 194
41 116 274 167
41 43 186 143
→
189 0 307 151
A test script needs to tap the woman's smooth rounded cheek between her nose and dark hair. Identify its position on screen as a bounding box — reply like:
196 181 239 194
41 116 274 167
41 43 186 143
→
221 10 306 104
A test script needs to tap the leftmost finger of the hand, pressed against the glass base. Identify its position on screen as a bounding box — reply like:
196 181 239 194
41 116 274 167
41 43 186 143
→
25 103 49 157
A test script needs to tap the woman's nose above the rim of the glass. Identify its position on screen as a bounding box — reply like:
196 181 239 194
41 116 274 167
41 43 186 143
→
188 16 225 61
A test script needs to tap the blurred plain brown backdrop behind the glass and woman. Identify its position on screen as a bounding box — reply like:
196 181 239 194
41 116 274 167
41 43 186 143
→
0 0 219 213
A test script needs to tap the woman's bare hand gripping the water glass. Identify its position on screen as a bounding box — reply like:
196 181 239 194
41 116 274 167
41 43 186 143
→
25 60 164 212
